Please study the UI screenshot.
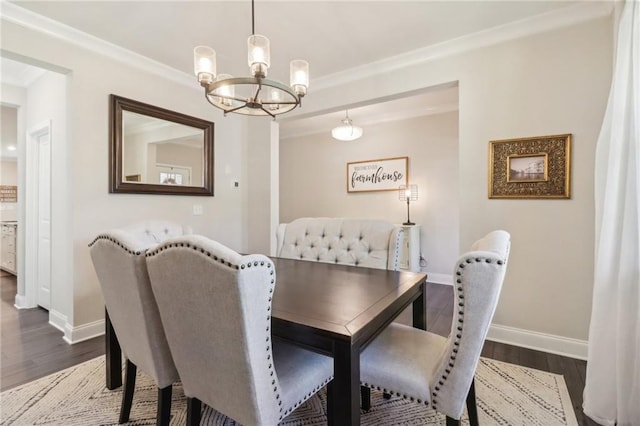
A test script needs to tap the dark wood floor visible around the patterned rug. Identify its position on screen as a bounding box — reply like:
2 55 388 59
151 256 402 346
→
0 275 597 426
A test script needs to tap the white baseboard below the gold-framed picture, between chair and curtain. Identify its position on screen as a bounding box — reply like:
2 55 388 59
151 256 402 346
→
487 324 588 360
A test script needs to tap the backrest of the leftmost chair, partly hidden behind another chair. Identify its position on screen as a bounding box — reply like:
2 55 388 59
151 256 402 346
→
89 221 190 388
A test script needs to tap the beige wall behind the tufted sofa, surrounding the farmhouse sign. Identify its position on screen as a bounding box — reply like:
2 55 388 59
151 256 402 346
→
280 111 460 282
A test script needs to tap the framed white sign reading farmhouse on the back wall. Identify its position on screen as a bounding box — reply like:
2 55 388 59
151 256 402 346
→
347 157 409 192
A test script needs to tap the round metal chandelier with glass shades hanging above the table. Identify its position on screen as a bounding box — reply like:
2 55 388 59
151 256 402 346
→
193 0 309 119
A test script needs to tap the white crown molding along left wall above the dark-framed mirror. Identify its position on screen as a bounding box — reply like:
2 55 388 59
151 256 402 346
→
1 0 196 90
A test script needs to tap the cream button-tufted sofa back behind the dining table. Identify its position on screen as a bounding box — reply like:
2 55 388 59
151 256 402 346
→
276 217 403 271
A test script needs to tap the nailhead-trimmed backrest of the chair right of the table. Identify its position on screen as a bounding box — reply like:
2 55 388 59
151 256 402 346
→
431 231 511 419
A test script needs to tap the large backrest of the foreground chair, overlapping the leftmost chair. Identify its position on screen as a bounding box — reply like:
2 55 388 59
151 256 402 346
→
147 235 281 425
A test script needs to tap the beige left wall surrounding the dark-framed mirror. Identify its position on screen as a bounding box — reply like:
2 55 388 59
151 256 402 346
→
2 21 246 340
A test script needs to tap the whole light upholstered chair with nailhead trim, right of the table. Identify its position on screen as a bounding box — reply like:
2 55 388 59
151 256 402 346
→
360 231 510 425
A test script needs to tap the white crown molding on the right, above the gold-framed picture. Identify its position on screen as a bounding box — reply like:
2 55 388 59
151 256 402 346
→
312 0 614 90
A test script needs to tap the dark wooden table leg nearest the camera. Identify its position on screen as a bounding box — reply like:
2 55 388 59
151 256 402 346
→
327 342 360 426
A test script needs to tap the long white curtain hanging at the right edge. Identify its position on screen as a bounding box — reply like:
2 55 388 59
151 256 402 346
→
583 0 640 425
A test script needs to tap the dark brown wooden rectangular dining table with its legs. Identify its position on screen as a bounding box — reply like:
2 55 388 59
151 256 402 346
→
105 257 427 426
